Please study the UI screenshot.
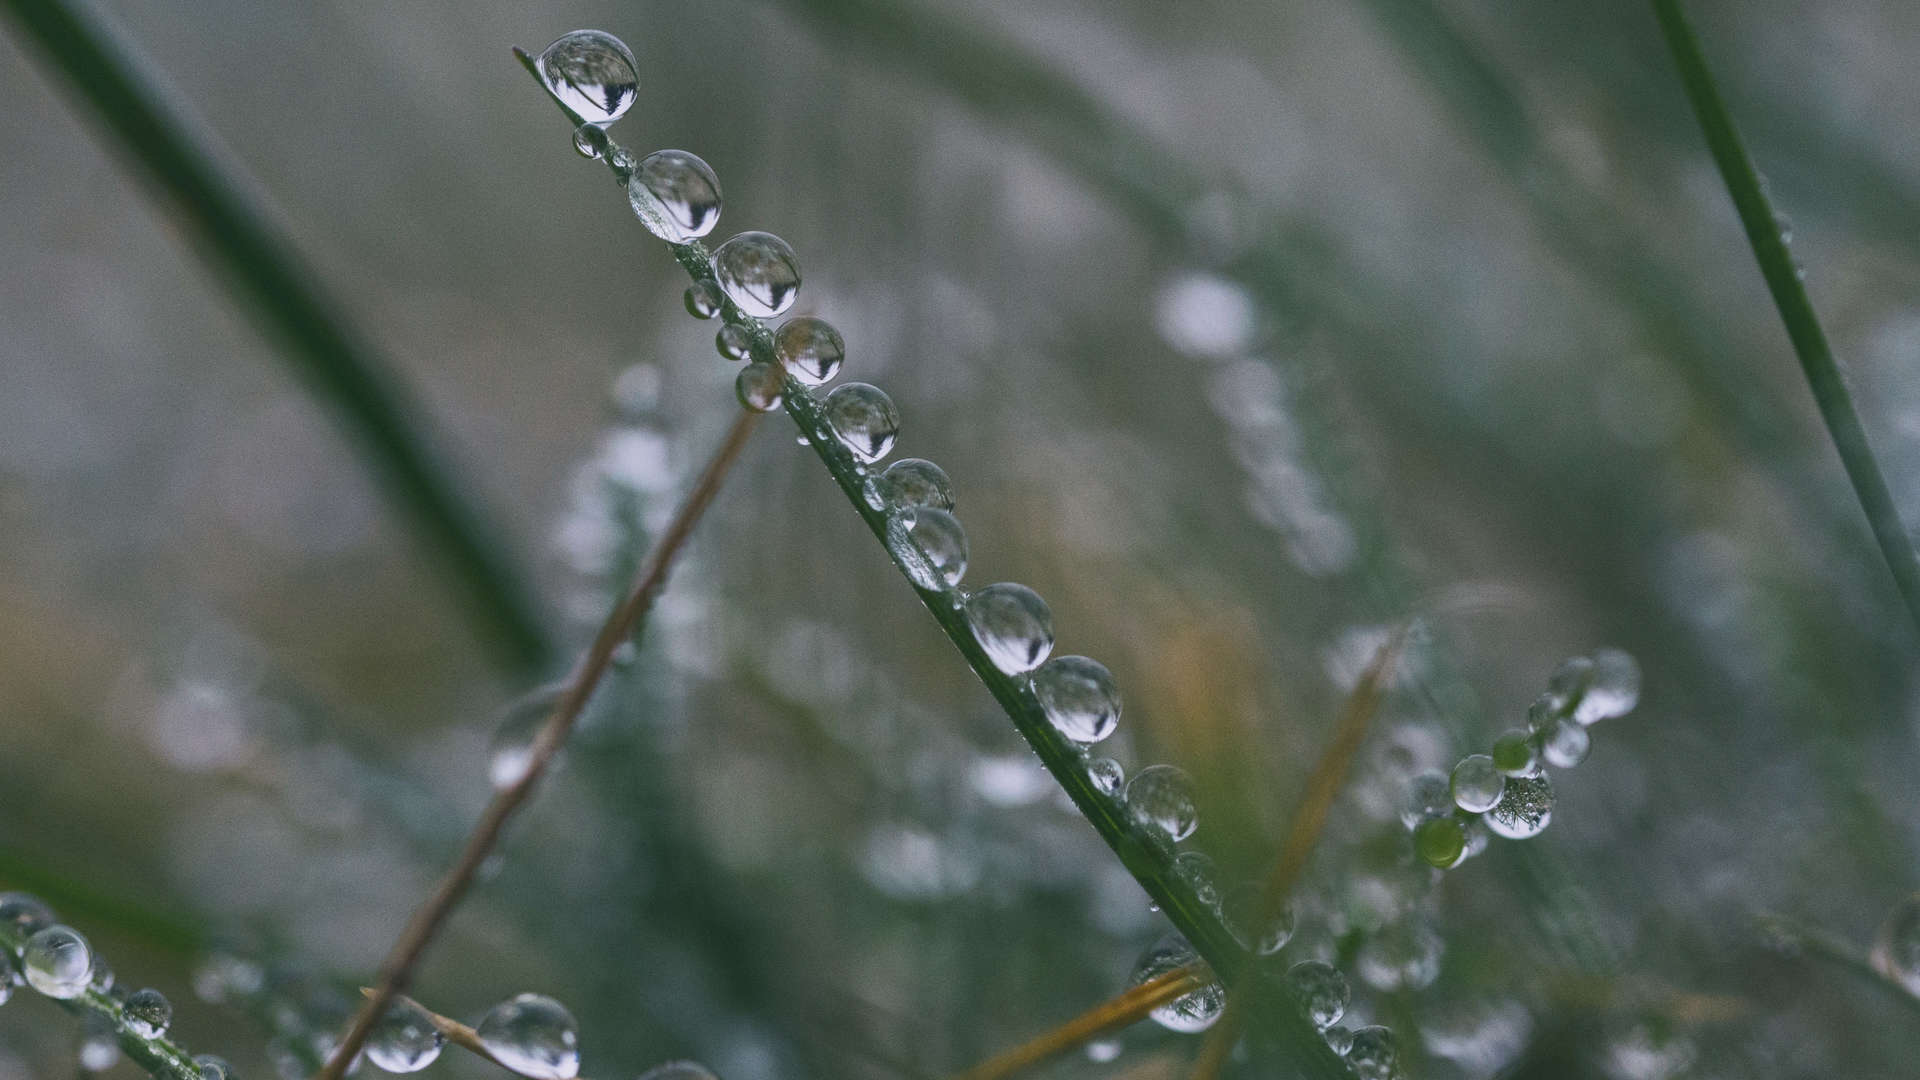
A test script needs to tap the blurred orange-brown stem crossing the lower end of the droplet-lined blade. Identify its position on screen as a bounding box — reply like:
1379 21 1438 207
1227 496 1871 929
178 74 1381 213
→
1192 623 1411 1080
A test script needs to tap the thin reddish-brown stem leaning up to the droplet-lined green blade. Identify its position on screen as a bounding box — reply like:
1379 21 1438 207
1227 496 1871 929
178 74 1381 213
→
315 411 760 1080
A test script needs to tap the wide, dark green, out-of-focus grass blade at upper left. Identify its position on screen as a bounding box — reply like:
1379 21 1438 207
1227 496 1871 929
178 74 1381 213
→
0 0 549 667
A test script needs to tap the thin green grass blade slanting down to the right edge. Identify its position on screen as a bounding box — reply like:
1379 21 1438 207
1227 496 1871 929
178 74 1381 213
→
1653 0 1920 628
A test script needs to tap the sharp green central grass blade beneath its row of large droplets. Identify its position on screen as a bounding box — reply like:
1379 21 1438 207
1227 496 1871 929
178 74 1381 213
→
513 48 1352 1080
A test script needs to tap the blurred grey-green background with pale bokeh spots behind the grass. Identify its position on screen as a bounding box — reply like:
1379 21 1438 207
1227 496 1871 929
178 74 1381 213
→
0 0 1920 1080
